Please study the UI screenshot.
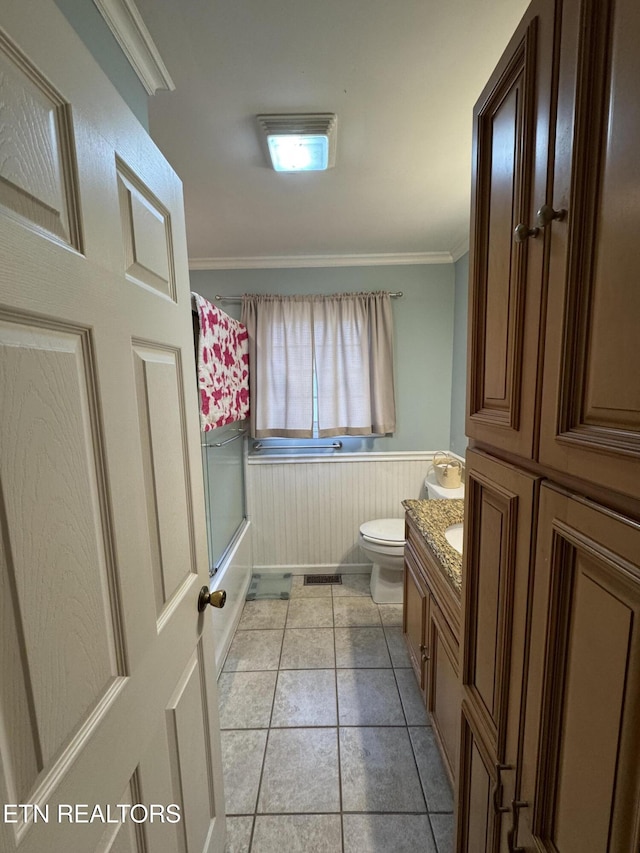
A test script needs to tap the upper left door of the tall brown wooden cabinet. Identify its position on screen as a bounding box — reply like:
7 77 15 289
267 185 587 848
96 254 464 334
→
466 0 555 457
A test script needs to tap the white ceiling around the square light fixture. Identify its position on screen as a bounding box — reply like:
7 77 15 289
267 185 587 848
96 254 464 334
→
137 0 528 268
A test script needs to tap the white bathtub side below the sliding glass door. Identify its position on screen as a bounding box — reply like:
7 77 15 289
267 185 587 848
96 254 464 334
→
207 521 252 678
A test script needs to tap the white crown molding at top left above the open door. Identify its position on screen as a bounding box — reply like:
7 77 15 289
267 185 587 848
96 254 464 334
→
93 0 176 95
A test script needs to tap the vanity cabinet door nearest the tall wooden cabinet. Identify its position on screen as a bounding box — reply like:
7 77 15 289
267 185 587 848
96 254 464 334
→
427 600 460 785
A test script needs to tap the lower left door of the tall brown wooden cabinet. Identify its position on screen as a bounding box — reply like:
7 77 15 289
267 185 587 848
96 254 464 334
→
458 450 537 853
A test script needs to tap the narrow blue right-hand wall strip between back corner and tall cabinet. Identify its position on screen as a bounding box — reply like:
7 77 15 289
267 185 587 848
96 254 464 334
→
449 252 469 456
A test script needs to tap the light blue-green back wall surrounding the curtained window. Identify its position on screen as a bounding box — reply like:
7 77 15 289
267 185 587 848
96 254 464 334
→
191 264 455 451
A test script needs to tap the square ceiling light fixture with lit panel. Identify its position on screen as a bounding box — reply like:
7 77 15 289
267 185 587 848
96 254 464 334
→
256 113 338 172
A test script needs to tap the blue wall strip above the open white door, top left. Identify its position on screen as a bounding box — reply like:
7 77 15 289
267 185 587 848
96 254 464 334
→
55 0 149 131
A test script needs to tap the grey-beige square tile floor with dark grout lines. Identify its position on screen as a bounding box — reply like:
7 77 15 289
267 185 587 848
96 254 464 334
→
218 575 453 853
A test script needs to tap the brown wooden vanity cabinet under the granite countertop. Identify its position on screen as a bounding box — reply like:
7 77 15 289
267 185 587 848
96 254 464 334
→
403 515 461 784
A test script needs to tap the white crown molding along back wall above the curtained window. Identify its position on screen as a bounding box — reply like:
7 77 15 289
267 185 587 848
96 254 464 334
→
189 252 454 270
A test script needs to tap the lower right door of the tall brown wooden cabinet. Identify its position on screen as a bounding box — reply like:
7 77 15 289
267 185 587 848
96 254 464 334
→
514 486 640 853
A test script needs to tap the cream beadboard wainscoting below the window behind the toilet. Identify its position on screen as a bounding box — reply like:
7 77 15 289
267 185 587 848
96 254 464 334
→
247 451 433 574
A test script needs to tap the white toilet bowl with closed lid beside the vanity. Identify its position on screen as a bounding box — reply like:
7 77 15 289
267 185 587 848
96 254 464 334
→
358 518 404 604
